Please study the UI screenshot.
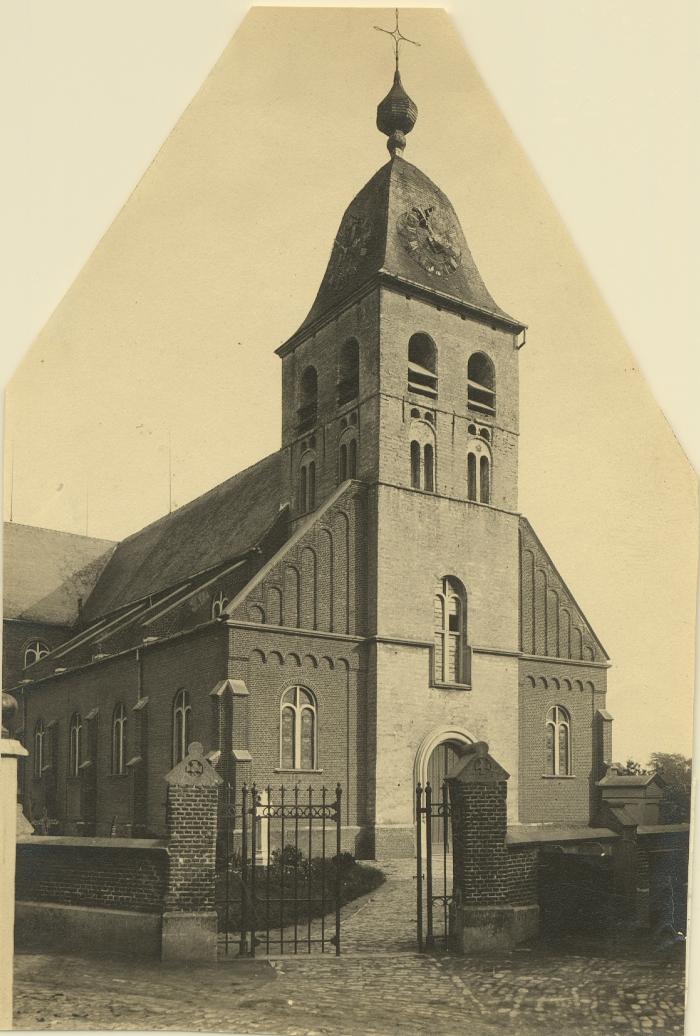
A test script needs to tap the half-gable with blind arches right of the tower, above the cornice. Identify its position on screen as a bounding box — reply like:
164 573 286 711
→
520 518 608 662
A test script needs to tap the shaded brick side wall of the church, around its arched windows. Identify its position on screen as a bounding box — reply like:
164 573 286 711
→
24 625 228 836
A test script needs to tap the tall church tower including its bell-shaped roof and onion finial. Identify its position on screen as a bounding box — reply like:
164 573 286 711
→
278 70 525 855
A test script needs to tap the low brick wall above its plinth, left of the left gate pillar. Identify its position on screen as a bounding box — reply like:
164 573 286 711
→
17 837 168 914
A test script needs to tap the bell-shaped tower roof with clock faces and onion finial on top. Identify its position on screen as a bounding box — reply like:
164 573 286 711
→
278 69 526 354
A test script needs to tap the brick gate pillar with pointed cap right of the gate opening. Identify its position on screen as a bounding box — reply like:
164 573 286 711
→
447 742 539 953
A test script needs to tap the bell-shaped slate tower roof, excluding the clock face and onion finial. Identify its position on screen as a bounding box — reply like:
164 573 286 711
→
282 155 525 349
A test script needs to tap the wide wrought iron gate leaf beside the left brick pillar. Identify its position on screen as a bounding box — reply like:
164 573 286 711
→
216 783 342 957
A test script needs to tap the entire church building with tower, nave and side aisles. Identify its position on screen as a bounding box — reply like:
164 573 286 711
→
4 62 611 858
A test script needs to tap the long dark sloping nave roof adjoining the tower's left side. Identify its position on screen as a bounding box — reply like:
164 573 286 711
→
78 453 281 622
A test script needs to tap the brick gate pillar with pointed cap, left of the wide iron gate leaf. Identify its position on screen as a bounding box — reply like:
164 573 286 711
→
161 741 222 960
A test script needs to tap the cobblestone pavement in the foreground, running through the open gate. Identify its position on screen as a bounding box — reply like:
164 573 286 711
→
16 861 683 1036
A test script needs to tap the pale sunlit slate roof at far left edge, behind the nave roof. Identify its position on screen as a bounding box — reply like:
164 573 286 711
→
3 522 116 626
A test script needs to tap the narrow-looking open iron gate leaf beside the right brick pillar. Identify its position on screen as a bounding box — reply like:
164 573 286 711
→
415 781 453 952
